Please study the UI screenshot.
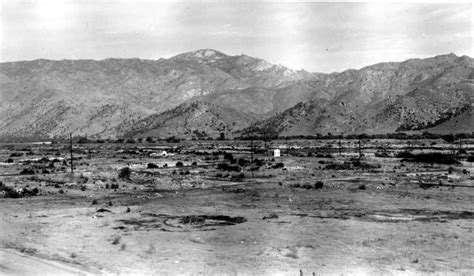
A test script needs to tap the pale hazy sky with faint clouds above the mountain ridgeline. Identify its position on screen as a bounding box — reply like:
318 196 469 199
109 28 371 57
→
0 0 473 72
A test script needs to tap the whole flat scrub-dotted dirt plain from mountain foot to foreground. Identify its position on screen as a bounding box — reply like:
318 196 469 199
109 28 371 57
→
0 140 474 275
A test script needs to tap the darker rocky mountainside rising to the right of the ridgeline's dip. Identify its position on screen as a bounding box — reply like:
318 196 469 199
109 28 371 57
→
244 54 474 135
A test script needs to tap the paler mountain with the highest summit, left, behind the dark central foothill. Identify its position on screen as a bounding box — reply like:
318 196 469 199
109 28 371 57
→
0 49 311 137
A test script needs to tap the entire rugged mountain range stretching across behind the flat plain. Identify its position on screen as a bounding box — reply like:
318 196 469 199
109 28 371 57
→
0 49 474 138
